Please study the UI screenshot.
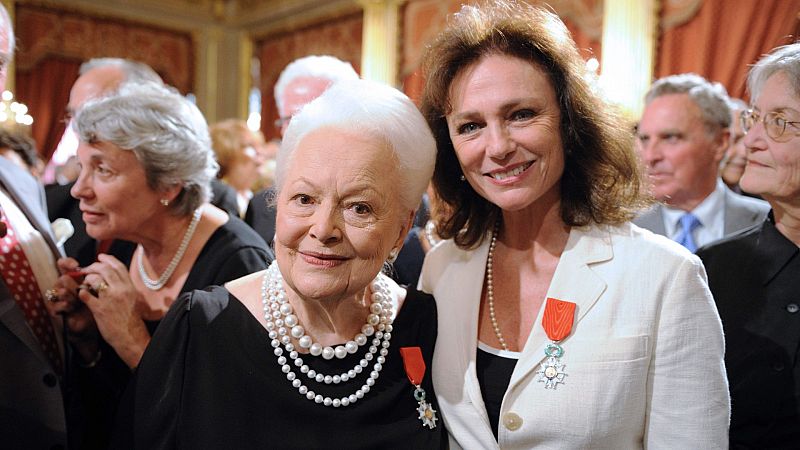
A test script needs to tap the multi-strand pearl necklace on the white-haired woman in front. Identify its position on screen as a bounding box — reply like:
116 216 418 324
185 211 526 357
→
261 261 393 408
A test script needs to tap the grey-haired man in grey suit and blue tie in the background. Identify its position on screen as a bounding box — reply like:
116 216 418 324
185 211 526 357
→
634 74 769 251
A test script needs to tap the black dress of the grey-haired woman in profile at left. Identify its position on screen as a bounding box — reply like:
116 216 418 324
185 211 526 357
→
69 216 272 449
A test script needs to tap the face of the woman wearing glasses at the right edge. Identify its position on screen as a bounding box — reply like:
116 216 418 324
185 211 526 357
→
739 72 800 203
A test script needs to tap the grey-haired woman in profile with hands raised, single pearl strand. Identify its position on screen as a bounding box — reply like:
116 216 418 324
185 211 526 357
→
49 83 272 368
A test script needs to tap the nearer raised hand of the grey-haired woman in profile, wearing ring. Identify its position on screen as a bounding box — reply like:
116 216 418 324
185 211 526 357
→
78 254 150 368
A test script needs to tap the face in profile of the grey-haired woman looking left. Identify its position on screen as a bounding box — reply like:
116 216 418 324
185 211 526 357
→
70 141 166 242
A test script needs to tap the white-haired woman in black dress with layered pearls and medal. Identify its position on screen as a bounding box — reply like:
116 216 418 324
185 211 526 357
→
115 80 445 449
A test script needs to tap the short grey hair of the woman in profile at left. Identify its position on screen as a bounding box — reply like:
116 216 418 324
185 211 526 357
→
73 83 219 215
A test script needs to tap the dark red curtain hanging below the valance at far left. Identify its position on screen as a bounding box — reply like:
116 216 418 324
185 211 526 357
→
17 58 81 161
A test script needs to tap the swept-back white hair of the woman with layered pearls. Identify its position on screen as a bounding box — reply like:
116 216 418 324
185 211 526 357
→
275 80 436 210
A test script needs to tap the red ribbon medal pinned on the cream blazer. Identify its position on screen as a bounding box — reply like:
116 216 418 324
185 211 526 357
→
536 298 576 389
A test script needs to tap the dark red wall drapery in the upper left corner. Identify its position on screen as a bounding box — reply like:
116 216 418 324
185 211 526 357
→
14 4 195 160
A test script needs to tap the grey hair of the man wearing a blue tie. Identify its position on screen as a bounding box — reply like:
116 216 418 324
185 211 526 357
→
645 73 731 133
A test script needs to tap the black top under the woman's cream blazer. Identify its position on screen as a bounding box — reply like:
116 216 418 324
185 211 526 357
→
475 348 517 440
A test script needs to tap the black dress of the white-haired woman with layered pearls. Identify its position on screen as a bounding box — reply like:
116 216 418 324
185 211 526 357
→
113 287 447 449
